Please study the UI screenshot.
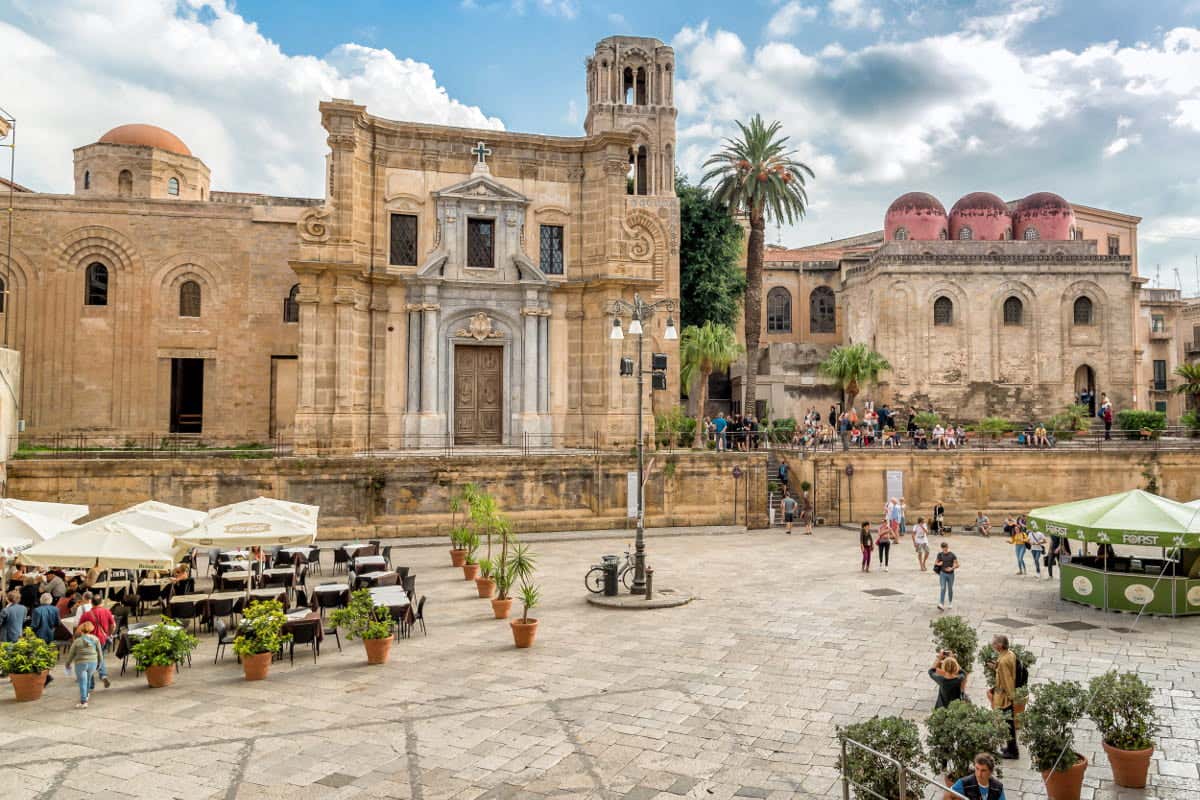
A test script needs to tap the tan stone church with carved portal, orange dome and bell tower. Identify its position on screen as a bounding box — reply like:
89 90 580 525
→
5 36 679 452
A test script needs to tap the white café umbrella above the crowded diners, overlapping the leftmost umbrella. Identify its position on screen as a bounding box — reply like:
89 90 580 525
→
20 519 175 570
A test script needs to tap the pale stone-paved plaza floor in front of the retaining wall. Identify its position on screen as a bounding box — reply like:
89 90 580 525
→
0 529 1200 800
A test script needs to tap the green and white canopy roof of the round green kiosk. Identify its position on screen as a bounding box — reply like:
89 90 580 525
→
1027 489 1200 548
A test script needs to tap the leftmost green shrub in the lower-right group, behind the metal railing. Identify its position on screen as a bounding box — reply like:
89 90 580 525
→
838 717 924 800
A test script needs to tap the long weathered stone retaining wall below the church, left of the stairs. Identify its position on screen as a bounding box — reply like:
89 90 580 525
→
8 453 767 539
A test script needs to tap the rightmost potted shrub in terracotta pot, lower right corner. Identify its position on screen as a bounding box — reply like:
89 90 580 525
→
1087 669 1158 789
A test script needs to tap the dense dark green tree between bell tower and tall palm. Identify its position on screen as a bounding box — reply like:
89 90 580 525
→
676 175 746 327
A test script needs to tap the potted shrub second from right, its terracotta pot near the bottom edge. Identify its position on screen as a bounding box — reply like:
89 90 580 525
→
1021 680 1087 800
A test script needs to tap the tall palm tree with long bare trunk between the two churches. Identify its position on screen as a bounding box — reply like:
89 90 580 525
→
700 114 814 414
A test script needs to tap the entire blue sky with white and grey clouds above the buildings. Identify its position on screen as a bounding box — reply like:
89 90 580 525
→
0 0 1200 295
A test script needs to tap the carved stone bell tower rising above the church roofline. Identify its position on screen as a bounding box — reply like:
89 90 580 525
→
583 36 677 196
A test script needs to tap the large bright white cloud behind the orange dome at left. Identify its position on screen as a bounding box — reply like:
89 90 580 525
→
0 0 503 196
